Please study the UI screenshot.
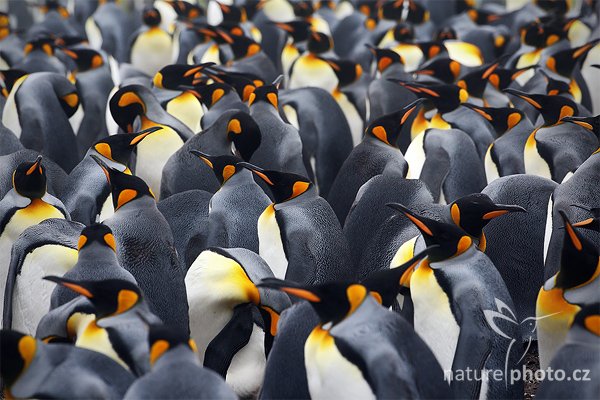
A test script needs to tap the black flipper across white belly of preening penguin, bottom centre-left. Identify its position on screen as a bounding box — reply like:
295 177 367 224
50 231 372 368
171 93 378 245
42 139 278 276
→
204 303 254 378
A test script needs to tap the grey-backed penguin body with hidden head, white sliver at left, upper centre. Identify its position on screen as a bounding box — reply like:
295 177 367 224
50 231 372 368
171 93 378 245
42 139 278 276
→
280 88 352 197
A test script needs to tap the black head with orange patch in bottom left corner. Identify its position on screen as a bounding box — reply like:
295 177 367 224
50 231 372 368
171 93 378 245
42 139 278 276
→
0 329 38 388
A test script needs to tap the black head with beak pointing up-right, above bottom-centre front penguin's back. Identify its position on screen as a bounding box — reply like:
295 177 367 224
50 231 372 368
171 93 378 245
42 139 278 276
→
361 245 437 308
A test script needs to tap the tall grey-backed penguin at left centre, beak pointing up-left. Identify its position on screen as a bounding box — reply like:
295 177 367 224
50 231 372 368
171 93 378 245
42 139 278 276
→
93 156 189 332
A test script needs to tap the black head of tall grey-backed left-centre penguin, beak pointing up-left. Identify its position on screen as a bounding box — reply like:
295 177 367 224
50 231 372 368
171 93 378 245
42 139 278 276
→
91 155 156 211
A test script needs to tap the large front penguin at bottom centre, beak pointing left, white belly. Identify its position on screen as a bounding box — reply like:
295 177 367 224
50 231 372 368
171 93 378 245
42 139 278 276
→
259 279 449 399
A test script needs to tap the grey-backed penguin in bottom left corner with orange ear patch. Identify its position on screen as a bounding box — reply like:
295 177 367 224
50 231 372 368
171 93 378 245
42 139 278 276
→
0 329 135 398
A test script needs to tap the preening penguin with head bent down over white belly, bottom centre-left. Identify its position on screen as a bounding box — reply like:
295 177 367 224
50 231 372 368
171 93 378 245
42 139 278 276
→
185 247 291 398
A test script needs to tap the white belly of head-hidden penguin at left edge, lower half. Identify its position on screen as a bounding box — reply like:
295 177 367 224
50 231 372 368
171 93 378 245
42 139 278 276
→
12 244 77 335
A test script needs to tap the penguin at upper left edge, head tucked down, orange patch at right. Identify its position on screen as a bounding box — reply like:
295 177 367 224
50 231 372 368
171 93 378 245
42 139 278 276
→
2 72 80 173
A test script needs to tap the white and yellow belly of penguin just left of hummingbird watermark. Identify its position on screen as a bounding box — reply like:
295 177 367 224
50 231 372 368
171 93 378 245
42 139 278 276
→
410 265 460 371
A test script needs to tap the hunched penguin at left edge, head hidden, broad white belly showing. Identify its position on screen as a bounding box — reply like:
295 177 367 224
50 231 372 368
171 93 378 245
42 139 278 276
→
2 218 83 335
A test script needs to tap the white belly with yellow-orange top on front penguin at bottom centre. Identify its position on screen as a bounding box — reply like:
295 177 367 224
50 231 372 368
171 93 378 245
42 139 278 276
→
304 328 375 400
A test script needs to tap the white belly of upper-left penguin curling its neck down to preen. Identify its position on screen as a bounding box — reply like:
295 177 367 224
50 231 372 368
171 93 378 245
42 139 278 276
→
135 128 183 194
